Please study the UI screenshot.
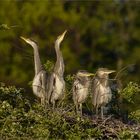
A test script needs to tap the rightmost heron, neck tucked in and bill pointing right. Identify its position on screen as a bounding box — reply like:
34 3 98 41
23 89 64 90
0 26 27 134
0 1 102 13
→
92 68 115 119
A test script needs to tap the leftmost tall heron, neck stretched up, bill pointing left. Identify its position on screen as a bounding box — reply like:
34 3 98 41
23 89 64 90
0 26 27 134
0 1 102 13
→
20 36 47 105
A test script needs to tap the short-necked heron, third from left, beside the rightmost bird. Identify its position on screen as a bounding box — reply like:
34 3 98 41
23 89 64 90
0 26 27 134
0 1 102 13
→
72 70 94 116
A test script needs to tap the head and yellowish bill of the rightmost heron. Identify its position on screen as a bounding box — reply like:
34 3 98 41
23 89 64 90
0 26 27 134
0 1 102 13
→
97 68 116 76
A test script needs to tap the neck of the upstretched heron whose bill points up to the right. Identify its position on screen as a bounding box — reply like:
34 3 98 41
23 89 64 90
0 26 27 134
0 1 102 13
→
54 42 64 75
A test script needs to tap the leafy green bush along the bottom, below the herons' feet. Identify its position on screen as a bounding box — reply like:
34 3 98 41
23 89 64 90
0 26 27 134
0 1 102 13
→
0 84 139 139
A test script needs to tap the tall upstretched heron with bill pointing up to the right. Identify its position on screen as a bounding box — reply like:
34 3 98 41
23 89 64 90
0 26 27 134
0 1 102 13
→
48 31 67 109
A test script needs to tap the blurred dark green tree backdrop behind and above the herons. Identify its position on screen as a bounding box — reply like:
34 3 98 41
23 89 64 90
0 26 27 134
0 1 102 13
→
0 0 140 88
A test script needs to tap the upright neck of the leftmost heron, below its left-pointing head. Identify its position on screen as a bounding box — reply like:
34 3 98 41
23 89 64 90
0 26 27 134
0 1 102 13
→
33 45 42 75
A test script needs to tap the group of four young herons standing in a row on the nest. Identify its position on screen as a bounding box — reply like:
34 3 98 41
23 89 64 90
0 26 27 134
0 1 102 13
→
21 31 115 118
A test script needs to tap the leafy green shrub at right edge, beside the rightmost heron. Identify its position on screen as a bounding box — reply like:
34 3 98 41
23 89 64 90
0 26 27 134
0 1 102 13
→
120 82 140 122
